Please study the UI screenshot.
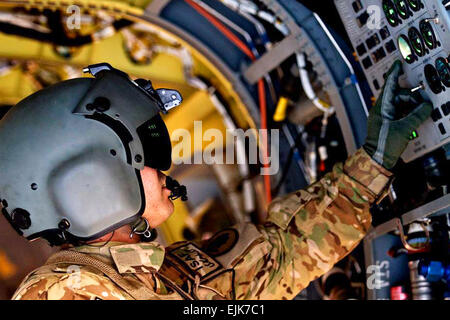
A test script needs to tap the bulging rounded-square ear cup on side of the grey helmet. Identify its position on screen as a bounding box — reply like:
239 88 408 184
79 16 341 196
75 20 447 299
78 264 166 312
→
48 147 142 238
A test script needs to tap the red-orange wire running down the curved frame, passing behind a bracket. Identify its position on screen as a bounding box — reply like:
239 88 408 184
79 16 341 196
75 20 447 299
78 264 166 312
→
185 0 272 203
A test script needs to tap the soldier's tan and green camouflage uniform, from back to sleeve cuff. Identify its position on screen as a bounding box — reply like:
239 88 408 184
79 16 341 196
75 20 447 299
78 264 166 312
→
13 149 391 299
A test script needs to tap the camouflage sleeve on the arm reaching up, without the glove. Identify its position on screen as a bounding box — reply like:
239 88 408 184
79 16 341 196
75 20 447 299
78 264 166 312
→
234 149 392 299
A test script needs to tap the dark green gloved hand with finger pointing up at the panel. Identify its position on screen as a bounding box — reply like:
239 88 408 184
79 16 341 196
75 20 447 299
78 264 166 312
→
363 60 433 170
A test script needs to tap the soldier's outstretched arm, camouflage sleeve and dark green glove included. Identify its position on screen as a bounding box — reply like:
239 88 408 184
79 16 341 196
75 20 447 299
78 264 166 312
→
233 61 432 299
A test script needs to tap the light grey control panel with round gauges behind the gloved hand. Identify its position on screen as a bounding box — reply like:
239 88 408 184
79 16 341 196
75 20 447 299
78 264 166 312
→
335 0 450 162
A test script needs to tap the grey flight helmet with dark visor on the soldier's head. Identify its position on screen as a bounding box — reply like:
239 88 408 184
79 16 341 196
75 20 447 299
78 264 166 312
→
0 64 182 245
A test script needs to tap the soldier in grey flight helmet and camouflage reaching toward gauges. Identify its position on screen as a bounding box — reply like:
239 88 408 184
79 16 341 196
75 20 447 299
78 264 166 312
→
0 62 432 300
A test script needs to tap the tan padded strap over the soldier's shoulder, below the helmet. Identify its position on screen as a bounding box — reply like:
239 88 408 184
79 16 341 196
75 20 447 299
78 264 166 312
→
45 250 160 300
